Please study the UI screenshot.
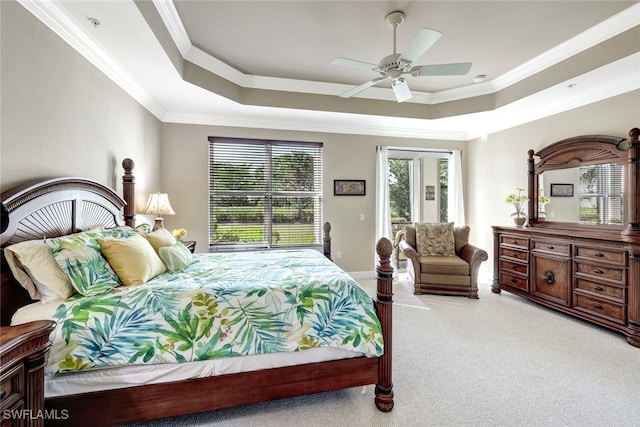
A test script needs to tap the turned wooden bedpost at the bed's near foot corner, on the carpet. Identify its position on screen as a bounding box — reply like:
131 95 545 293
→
375 237 393 412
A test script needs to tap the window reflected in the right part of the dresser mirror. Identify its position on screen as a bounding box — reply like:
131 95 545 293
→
579 164 624 224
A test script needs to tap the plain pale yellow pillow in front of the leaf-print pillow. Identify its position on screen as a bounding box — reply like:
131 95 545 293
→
98 235 167 286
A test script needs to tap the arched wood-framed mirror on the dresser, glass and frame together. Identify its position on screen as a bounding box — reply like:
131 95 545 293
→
528 135 628 228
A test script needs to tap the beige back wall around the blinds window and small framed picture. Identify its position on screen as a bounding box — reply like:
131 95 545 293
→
162 123 464 272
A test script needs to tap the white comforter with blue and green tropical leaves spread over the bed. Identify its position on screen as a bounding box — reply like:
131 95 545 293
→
46 250 383 374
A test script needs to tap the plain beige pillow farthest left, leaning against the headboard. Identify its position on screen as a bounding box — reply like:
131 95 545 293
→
5 240 75 302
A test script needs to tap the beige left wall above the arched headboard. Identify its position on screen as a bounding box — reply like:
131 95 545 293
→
0 1 160 211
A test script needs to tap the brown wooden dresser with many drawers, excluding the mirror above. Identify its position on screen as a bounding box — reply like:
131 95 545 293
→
492 226 640 347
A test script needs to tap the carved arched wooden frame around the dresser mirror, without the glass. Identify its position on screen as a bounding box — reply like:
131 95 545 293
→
527 135 630 231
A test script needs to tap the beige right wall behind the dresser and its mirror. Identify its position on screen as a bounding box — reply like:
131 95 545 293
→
464 91 640 275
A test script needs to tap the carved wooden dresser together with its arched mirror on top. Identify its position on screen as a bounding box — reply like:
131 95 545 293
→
492 128 640 347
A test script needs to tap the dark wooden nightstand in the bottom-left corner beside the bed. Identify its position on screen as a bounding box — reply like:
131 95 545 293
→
0 321 55 427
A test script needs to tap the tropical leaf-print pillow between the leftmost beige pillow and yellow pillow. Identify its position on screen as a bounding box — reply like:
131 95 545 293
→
46 229 135 296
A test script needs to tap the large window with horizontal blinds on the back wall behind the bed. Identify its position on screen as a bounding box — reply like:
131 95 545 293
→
209 137 322 250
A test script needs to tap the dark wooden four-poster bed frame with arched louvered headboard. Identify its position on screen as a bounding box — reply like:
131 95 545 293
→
0 159 394 426
